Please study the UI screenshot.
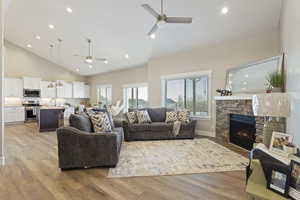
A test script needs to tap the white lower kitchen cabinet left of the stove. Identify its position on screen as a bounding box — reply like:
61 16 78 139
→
4 106 25 123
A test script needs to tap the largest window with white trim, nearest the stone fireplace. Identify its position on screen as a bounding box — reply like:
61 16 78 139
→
162 72 210 118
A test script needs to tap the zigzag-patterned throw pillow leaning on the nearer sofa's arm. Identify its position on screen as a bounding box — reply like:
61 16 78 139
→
90 112 112 133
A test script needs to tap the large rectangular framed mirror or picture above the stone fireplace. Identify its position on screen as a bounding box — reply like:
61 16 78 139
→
225 55 283 94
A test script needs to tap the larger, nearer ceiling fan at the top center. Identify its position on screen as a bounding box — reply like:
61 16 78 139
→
142 0 193 38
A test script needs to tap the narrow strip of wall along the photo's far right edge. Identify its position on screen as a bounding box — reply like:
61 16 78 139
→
281 0 300 146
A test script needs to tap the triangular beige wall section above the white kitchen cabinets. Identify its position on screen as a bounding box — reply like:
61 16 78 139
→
4 41 86 82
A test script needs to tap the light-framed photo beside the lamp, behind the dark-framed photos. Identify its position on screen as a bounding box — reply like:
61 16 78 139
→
270 132 295 157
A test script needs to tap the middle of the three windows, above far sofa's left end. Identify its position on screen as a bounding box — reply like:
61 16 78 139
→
124 84 148 111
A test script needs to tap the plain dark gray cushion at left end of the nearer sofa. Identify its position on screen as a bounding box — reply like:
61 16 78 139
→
69 114 93 133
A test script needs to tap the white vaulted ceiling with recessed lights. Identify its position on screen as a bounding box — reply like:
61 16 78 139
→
5 0 281 75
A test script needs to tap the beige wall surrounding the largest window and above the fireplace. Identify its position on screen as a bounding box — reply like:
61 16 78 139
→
148 30 280 132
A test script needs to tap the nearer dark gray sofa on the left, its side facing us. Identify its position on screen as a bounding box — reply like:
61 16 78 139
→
57 114 124 170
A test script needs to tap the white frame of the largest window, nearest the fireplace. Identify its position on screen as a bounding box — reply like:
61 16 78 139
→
161 70 212 120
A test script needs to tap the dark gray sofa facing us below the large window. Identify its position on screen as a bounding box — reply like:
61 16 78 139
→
123 108 196 141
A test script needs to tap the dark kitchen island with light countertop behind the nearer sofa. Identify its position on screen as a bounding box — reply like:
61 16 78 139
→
37 106 65 132
